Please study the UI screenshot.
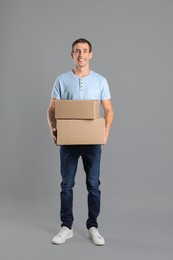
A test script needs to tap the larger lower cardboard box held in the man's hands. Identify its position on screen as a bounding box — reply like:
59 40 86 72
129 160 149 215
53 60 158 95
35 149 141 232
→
57 117 105 145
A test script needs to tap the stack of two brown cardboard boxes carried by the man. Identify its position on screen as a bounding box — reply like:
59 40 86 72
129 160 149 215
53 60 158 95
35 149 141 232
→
55 100 105 145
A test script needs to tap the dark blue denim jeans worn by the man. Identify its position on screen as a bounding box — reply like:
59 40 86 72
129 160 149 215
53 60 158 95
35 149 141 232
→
60 145 101 229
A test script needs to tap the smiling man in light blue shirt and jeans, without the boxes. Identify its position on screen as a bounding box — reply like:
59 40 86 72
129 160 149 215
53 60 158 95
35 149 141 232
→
47 38 113 245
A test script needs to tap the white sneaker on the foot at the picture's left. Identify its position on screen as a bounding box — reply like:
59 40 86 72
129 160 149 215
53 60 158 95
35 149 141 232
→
52 227 73 245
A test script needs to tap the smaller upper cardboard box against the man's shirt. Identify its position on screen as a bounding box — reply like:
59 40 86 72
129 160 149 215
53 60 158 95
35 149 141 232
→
55 99 100 119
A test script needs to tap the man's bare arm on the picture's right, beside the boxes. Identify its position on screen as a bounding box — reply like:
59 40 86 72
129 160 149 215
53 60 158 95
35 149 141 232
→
101 99 114 143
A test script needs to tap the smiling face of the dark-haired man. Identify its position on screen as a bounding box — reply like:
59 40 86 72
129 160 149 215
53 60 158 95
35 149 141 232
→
71 43 92 68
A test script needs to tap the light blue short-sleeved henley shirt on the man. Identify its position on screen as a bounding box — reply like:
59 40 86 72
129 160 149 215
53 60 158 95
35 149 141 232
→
51 71 111 100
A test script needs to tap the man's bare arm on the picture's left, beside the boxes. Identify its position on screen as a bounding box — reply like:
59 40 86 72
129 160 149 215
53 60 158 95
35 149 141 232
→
47 98 57 144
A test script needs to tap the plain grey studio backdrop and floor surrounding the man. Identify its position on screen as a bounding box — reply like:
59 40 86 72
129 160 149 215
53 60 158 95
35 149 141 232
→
0 0 173 260
